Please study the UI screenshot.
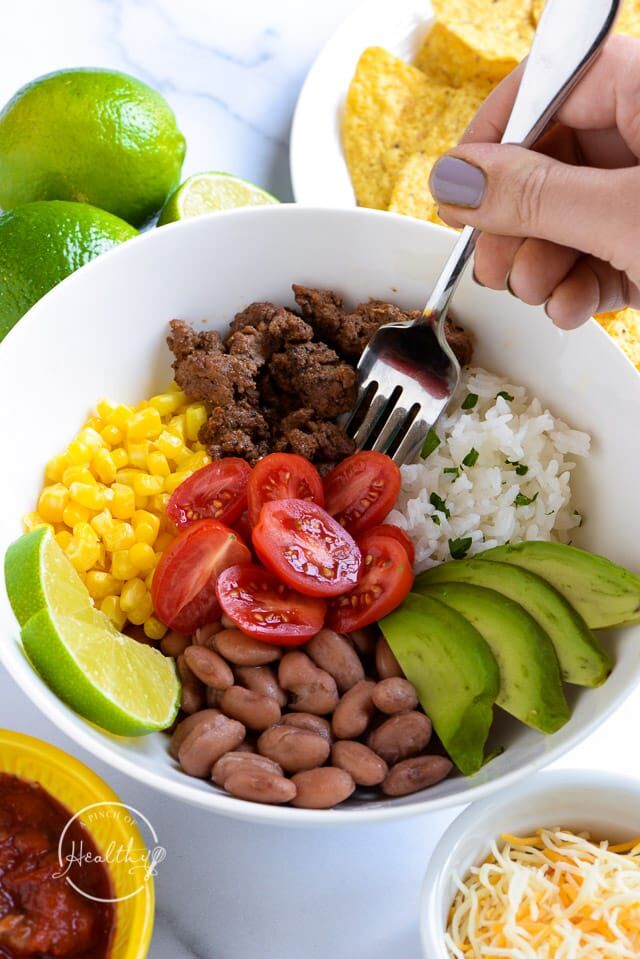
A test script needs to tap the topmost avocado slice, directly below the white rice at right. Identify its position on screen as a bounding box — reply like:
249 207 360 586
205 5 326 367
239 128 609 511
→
481 542 640 629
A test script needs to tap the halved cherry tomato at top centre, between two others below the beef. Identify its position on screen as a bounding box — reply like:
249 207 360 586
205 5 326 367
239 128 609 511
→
247 453 324 526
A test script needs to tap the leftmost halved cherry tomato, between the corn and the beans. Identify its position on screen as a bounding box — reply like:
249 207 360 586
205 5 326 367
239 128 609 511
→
151 519 251 636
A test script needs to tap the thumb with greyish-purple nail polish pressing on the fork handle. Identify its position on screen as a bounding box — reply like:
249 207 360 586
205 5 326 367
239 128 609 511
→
430 143 640 270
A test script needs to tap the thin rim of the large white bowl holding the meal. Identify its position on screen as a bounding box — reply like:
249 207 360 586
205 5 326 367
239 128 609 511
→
2 203 640 828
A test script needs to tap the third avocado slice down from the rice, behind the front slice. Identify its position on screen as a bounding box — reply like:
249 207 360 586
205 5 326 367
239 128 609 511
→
421 583 571 733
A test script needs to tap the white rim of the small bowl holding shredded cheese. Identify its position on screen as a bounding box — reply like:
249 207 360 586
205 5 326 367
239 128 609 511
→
419 767 640 959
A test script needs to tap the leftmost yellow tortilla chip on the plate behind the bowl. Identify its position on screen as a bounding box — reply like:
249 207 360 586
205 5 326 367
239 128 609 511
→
342 47 432 210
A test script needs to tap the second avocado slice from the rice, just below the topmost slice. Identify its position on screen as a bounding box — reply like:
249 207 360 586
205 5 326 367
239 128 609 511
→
413 557 613 686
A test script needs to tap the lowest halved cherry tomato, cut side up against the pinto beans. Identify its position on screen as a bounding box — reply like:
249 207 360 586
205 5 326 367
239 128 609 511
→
216 566 327 646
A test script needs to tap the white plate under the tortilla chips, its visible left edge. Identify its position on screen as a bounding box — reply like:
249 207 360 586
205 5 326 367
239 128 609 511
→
289 0 433 207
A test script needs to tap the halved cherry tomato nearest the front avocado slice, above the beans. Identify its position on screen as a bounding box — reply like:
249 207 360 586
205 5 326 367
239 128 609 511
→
327 532 413 633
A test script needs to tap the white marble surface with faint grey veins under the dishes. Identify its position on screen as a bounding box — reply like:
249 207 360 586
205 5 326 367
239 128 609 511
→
0 0 640 959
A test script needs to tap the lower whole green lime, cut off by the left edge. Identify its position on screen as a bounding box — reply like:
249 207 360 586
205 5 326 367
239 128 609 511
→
0 200 138 340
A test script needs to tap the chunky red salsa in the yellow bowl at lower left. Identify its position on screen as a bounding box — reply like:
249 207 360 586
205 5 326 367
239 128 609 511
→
0 773 116 959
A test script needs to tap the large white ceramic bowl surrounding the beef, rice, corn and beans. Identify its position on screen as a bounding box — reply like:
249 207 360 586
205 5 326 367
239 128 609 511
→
0 206 640 825
